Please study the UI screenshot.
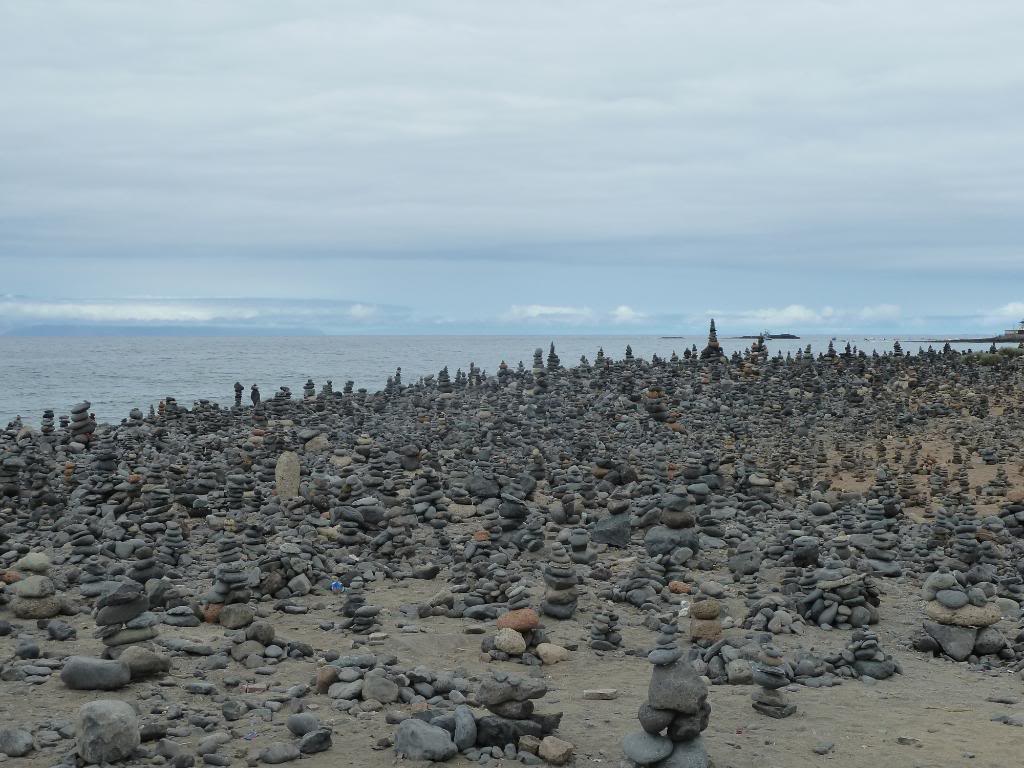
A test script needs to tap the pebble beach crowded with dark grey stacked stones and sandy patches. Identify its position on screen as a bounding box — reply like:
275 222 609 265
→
0 322 1024 768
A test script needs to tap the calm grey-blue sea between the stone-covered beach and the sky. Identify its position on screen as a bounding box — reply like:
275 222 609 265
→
0 336 1007 424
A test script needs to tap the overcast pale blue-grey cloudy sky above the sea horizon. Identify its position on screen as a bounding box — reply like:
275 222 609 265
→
0 0 1024 333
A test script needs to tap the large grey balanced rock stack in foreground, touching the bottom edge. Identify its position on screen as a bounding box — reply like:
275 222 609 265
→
623 623 711 768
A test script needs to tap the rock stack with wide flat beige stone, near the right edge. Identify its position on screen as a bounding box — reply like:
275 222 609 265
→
915 566 1007 662
